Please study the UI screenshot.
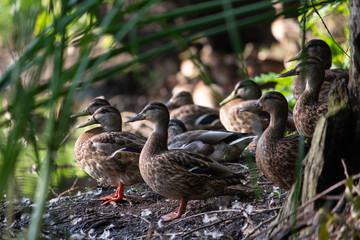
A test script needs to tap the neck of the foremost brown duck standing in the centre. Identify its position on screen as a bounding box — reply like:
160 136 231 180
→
144 119 169 155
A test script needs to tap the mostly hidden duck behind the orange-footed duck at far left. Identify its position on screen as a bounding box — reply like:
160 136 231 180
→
70 97 153 138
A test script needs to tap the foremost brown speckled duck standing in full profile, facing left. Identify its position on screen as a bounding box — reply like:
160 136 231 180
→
127 102 252 221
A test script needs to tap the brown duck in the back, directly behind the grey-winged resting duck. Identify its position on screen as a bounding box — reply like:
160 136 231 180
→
166 91 224 130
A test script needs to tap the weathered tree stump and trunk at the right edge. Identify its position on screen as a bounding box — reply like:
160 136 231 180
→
267 0 360 239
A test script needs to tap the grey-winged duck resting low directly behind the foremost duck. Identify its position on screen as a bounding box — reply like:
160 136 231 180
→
168 119 255 162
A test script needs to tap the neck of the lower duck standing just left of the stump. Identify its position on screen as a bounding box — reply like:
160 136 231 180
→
263 107 288 139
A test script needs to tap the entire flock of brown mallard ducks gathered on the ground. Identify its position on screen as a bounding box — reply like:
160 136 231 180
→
72 40 348 221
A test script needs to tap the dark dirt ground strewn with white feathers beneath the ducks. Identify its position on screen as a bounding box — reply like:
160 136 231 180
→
0 158 286 239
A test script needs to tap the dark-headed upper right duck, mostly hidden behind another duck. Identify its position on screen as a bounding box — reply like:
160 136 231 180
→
284 39 349 102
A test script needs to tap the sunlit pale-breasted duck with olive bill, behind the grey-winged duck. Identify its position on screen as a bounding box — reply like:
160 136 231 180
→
220 80 269 135
